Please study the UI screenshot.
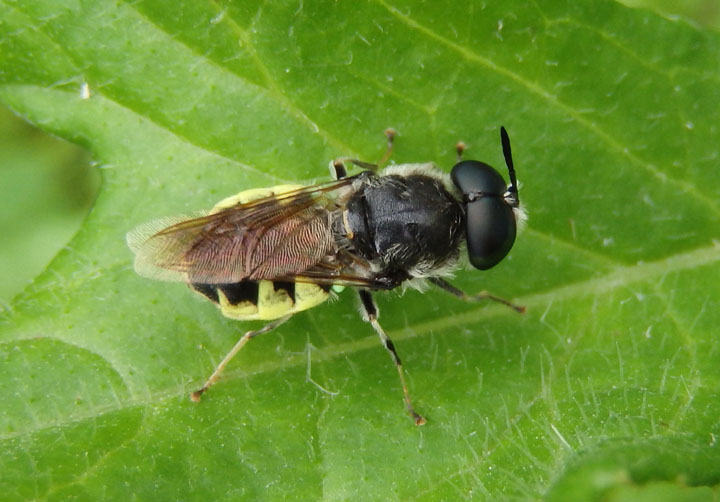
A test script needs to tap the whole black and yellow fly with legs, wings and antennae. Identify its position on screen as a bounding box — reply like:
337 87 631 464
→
128 128 524 425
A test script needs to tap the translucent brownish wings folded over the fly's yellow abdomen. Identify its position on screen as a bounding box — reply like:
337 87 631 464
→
127 177 355 284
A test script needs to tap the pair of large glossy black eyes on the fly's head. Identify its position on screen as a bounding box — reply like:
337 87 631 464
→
450 160 517 270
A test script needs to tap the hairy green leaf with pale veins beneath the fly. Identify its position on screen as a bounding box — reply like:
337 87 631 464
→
0 0 720 501
